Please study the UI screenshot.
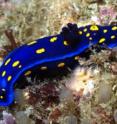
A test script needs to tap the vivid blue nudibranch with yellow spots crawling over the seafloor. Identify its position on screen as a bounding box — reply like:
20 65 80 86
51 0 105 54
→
0 24 117 106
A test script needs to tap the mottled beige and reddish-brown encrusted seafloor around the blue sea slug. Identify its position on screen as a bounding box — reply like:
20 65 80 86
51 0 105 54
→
0 0 117 124
